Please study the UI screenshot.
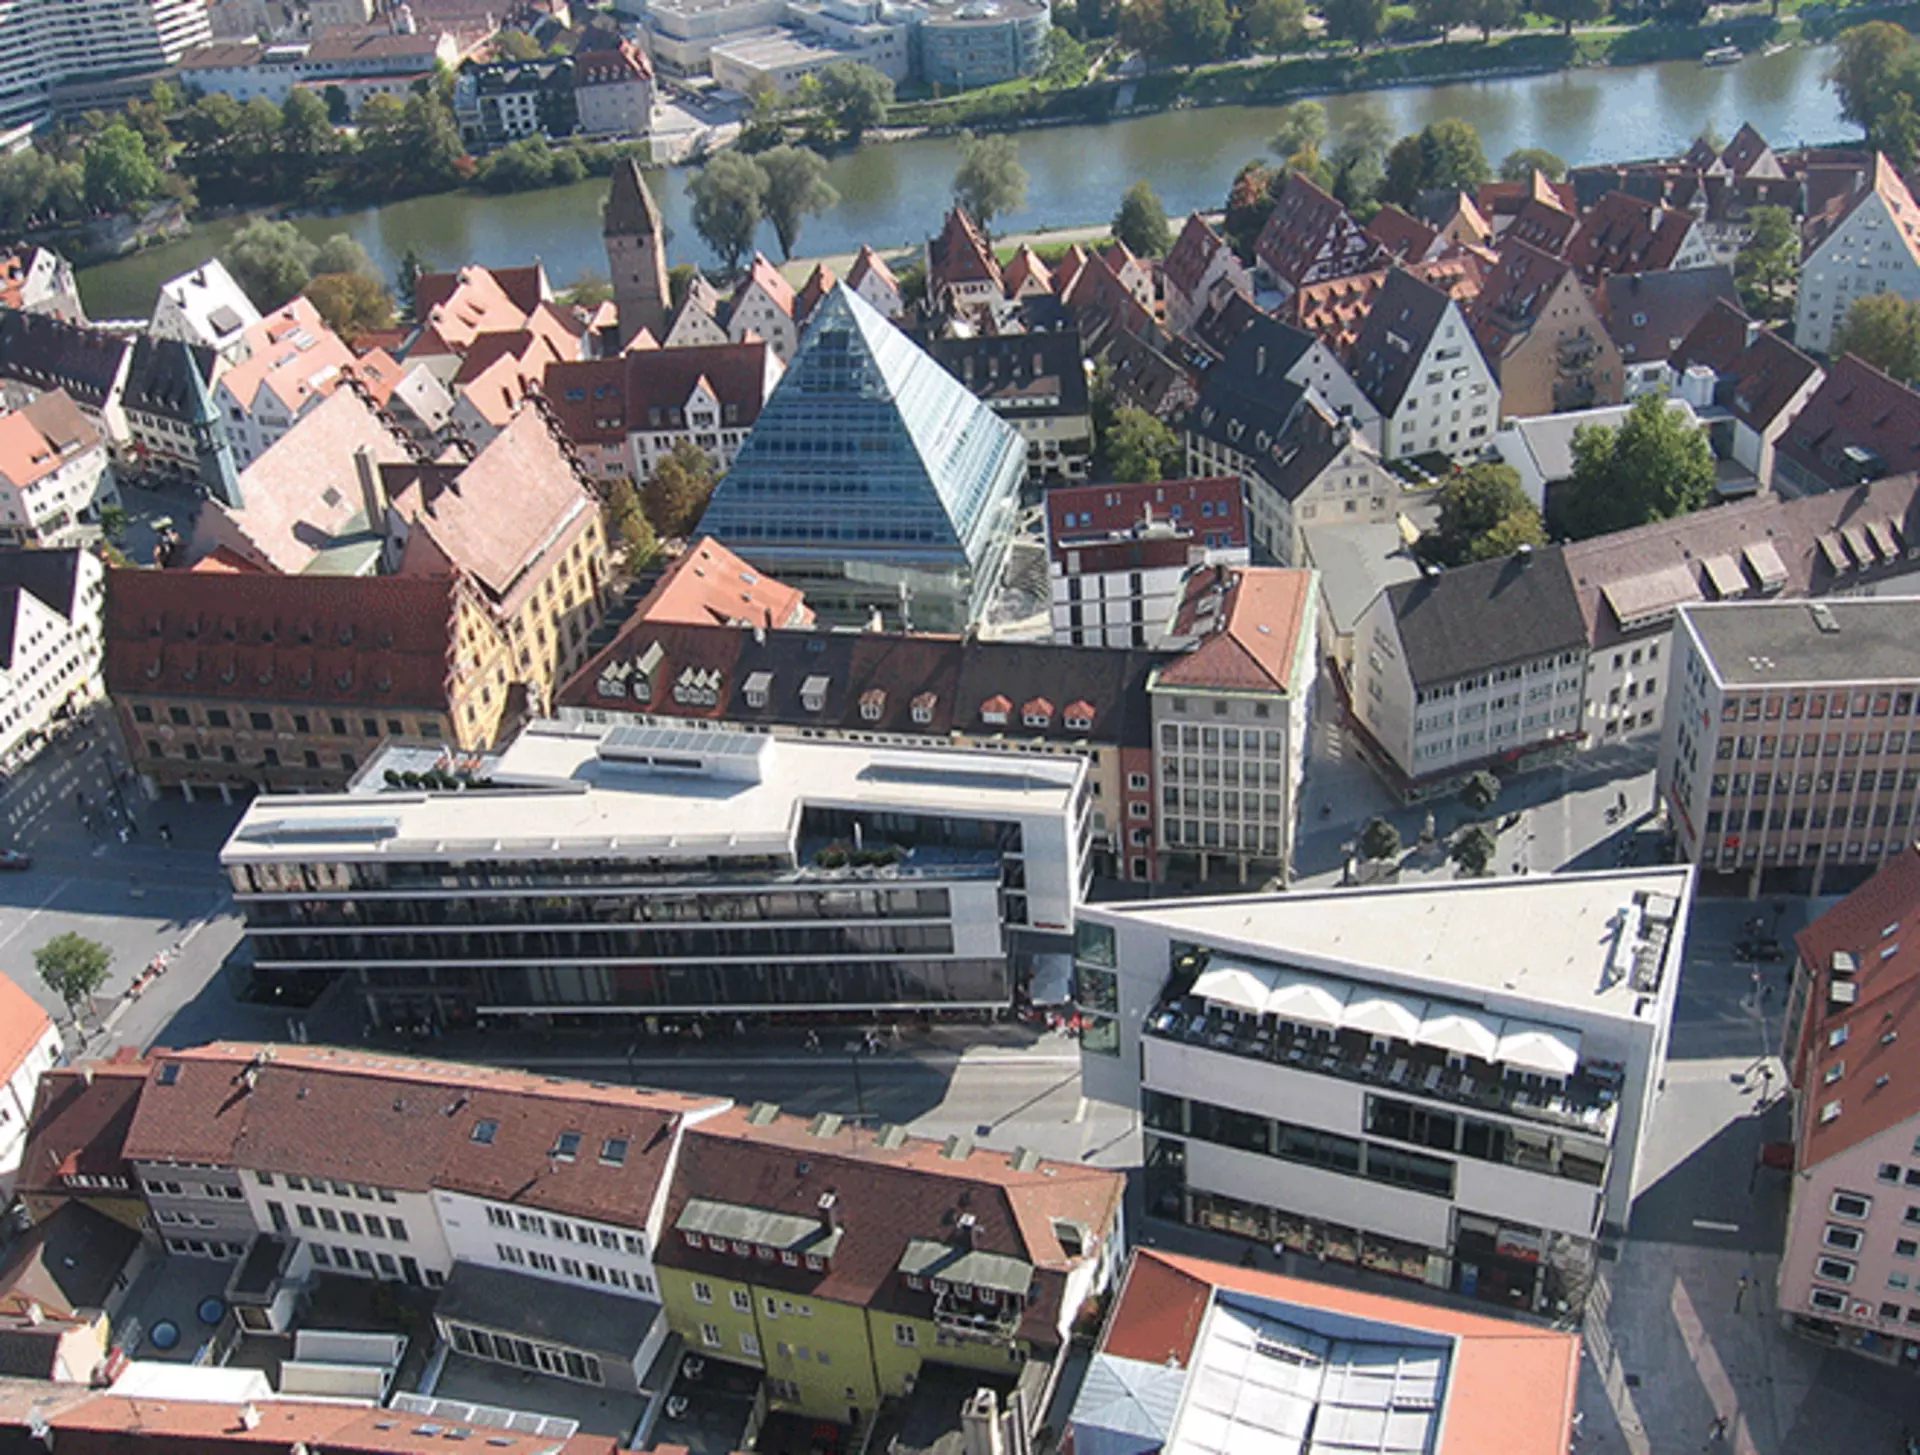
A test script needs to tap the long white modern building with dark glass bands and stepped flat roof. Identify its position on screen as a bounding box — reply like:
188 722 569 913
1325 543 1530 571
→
221 725 1092 1023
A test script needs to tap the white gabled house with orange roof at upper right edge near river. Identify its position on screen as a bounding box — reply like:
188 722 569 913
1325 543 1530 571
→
1793 152 1920 353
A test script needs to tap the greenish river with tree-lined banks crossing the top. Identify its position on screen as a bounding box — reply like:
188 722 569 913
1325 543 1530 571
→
81 48 1849 319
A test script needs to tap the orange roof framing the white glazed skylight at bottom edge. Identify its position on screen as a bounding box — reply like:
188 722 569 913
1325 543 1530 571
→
1100 1248 1580 1455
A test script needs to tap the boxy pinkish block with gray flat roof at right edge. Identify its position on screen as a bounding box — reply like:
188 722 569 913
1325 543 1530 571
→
1659 597 1920 894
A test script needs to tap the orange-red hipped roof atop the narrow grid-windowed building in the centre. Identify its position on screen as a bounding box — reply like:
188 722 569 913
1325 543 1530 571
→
1154 566 1313 693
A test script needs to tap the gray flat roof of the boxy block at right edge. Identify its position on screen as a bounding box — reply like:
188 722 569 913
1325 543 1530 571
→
1680 597 1920 687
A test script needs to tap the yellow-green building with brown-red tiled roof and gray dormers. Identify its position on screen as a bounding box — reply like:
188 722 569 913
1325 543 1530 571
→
655 1104 1125 1424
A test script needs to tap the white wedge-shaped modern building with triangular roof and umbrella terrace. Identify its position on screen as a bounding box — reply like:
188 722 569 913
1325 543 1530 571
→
1075 868 1692 1311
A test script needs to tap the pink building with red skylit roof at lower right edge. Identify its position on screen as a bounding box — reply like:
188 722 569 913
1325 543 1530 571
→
1778 845 1920 1369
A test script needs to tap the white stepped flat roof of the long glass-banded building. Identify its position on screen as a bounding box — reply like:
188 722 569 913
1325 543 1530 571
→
221 722 1085 864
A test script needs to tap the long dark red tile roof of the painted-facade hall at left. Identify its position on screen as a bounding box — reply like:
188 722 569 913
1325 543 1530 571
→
106 570 455 712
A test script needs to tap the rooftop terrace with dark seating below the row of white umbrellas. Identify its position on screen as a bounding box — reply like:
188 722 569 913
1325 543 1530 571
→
1146 996 1620 1142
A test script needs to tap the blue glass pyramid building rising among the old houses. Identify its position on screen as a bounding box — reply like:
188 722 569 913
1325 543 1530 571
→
699 286 1027 632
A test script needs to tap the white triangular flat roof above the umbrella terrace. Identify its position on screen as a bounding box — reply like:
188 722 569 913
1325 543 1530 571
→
1081 866 1693 1028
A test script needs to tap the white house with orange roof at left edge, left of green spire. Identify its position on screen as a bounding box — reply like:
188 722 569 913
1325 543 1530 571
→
0 390 119 545
